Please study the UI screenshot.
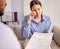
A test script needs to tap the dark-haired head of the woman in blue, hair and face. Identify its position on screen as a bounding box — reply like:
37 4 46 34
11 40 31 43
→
30 0 42 16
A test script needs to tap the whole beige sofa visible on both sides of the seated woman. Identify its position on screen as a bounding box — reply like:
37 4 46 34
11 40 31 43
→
10 25 60 49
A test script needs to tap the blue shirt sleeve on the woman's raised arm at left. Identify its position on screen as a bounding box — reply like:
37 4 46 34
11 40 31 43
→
21 17 31 38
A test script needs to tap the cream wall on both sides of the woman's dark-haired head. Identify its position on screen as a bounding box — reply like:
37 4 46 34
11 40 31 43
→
24 0 60 25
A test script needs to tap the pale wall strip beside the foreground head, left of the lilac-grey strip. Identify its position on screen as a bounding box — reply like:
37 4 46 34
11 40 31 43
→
2 0 12 21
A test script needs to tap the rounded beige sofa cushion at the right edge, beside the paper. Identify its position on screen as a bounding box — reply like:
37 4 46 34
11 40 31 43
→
53 26 60 45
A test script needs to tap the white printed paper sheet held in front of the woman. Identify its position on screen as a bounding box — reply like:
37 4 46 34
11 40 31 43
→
25 32 53 49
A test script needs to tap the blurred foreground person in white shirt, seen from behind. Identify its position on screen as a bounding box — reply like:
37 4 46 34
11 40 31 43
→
0 0 21 49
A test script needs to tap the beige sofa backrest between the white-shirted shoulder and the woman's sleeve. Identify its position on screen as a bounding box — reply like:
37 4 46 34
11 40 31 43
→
9 25 24 40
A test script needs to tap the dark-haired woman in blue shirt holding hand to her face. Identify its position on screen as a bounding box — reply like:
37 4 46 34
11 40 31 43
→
22 0 51 39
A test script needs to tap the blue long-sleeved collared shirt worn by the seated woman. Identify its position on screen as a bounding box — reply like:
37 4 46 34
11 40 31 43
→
21 15 51 38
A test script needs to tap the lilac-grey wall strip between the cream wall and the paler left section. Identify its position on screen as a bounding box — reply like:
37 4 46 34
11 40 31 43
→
12 0 24 24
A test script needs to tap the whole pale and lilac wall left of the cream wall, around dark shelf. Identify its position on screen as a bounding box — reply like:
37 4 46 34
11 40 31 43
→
2 0 24 24
